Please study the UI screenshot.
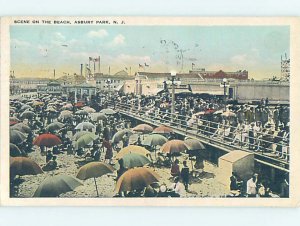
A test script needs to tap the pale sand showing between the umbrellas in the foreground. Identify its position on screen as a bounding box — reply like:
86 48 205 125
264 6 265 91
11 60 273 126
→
10 132 229 198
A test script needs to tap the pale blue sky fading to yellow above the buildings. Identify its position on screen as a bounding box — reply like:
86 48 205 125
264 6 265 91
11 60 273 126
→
10 25 290 79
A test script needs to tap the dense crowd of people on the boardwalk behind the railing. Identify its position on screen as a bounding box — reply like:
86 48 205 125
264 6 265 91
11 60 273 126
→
113 94 290 161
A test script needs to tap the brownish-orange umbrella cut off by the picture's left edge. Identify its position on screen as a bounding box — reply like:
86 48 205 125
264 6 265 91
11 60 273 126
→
10 157 43 176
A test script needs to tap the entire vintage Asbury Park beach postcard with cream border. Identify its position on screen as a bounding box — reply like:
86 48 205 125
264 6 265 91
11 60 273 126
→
0 16 300 207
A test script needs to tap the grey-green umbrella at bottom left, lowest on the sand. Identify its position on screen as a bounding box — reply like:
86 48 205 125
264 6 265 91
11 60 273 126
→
33 175 83 197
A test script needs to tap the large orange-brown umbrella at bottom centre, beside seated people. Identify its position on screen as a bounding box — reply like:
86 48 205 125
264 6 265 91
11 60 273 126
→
115 167 159 192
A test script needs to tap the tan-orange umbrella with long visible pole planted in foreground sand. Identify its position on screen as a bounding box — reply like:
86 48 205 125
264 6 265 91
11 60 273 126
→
76 162 114 197
